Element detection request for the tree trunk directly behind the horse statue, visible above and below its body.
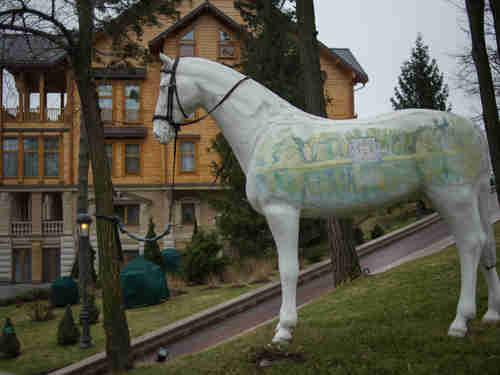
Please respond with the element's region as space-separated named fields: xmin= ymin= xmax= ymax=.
xmin=296 ymin=0 xmax=361 ymax=286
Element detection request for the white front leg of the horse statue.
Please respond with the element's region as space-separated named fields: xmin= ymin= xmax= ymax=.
xmin=263 ymin=203 xmax=300 ymax=343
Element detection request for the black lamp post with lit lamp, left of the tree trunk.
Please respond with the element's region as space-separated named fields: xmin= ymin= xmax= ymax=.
xmin=76 ymin=213 xmax=92 ymax=349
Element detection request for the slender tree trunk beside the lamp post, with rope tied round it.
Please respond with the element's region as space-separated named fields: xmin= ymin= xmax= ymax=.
xmin=72 ymin=0 xmax=132 ymax=373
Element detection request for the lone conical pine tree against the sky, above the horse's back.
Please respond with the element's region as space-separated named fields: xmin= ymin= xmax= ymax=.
xmin=391 ymin=34 xmax=451 ymax=111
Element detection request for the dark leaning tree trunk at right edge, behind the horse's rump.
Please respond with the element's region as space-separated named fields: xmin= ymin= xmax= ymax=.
xmin=465 ymin=0 xmax=500 ymax=206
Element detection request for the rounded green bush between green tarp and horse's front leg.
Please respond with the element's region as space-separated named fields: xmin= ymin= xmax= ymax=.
xmin=182 ymin=229 xmax=229 ymax=284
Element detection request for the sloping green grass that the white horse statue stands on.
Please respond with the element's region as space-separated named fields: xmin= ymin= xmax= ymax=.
xmin=131 ymin=224 xmax=500 ymax=375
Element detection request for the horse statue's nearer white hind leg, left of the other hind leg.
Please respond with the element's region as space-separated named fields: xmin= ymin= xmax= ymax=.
xmin=426 ymin=185 xmax=486 ymax=337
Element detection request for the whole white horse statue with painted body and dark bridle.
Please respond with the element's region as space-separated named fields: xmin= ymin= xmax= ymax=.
xmin=153 ymin=55 xmax=500 ymax=342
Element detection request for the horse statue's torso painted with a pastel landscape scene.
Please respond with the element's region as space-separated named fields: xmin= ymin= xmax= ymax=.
xmin=249 ymin=110 xmax=483 ymax=216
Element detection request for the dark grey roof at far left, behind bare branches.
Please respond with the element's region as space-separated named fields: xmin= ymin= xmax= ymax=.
xmin=0 ymin=33 xmax=66 ymax=67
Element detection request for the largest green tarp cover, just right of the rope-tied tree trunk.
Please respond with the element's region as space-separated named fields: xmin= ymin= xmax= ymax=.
xmin=120 ymin=256 xmax=170 ymax=308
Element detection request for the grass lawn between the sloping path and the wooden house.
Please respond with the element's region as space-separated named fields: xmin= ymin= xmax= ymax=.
xmin=0 ymin=285 xmax=262 ymax=375
